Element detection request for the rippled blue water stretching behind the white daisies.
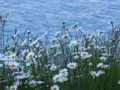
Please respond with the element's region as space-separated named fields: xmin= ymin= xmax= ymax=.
xmin=0 ymin=0 xmax=120 ymax=35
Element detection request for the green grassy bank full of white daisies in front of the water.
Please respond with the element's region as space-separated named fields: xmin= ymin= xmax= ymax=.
xmin=0 ymin=22 xmax=120 ymax=90
